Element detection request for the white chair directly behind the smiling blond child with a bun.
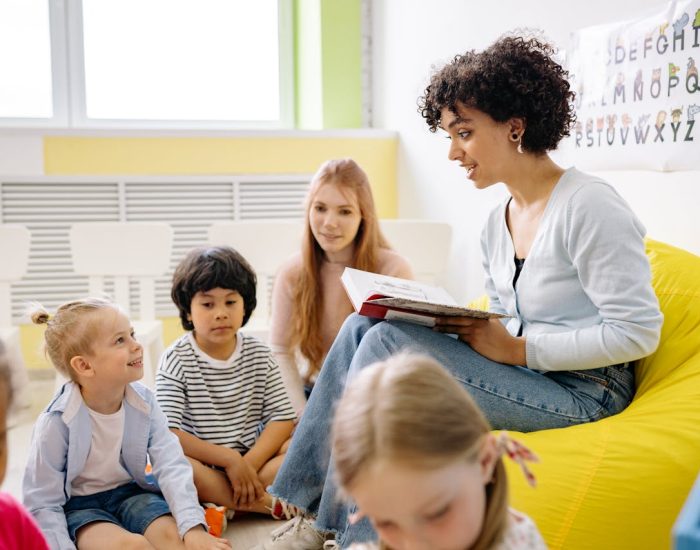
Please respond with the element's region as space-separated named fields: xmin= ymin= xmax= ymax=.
xmin=70 ymin=222 xmax=173 ymax=387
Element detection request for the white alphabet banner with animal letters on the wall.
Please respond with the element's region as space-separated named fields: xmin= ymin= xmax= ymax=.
xmin=564 ymin=0 xmax=700 ymax=171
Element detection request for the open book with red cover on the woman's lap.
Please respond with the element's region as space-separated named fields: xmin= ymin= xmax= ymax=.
xmin=340 ymin=267 xmax=507 ymax=327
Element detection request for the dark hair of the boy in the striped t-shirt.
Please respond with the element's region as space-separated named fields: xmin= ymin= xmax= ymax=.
xmin=170 ymin=246 xmax=258 ymax=330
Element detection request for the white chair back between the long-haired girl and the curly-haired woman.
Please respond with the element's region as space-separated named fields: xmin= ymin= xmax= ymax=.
xmin=379 ymin=219 xmax=452 ymax=284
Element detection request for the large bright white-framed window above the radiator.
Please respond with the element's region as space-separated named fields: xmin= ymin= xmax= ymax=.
xmin=0 ymin=0 xmax=293 ymax=128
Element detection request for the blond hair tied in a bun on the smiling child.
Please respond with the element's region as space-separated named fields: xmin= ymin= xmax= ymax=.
xmin=30 ymin=298 xmax=119 ymax=381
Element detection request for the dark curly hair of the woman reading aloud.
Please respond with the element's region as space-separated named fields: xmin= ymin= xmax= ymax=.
xmin=418 ymin=36 xmax=576 ymax=154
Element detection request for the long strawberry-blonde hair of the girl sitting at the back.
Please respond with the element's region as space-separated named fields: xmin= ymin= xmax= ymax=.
xmin=291 ymin=158 xmax=390 ymax=377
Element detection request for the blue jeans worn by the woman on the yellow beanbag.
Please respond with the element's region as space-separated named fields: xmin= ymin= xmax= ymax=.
xmin=270 ymin=314 xmax=634 ymax=547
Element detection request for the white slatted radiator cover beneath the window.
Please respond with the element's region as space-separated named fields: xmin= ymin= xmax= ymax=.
xmin=0 ymin=174 xmax=311 ymax=323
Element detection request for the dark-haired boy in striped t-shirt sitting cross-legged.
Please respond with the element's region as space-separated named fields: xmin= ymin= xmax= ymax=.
xmin=156 ymin=246 xmax=296 ymax=519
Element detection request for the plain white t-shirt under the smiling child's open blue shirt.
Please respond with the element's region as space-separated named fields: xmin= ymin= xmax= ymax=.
xmin=71 ymin=404 xmax=133 ymax=496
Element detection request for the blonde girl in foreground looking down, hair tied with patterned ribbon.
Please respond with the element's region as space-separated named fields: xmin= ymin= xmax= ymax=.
xmin=325 ymin=354 xmax=546 ymax=550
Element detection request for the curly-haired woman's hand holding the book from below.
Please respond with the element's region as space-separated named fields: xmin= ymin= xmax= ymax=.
xmin=433 ymin=317 xmax=527 ymax=366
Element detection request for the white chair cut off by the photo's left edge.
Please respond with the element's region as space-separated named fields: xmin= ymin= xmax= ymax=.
xmin=0 ymin=224 xmax=31 ymax=424
